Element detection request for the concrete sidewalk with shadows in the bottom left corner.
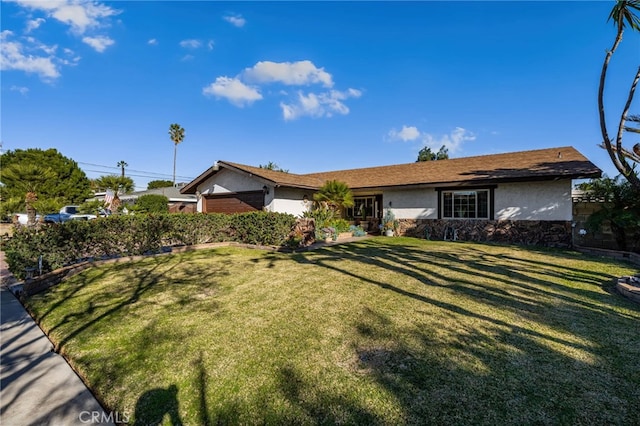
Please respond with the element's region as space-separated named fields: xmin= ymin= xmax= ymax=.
xmin=0 ymin=252 xmax=116 ymax=426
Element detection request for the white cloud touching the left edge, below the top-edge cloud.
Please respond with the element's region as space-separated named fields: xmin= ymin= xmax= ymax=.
xmin=0 ymin=30 xmax=60 ymax=80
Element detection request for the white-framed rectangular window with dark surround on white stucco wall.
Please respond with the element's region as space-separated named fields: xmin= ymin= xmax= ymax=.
xmin=441 ymin=189 xmax=492 ymax=219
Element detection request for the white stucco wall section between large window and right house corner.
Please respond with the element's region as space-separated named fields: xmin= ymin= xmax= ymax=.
xmin=495 ymin=179 xmax=572 ymax=220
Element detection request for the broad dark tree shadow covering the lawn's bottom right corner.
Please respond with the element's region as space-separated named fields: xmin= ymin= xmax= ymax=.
xmin=354 ymin=304 xmax=640 ymax=425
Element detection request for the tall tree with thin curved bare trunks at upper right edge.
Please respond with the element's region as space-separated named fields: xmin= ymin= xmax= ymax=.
xmin=598 ymin=0 xmax=640 ymax=191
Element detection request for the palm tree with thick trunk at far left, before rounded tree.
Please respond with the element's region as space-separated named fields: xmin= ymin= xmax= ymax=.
xmin=2 ymin=163 xmax=58 ymax=226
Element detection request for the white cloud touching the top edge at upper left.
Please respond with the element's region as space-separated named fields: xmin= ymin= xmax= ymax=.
xmin=17 ymin=0 xmax=120 ymax=34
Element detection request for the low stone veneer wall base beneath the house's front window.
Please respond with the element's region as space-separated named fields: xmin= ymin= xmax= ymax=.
xmin=398 ymin=219 xmax=572 ymax=247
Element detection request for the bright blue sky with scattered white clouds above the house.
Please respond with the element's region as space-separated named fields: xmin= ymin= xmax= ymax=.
xmin=0 ymin=0 xmax=640 ymax=189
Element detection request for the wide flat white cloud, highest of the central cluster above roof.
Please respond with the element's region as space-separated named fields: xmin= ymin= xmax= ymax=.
xmin=242 ymin=61 xmax=333 ymax=87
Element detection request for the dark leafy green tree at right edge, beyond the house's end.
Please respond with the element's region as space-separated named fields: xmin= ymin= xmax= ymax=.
xmin=578 ymin=176 xmax=640 ymax=251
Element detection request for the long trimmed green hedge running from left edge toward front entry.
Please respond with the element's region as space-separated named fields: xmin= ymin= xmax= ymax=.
xmin=3 ymin=211 xmax=296 ymax=279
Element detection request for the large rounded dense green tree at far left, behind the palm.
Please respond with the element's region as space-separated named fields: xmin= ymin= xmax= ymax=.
xmin=0 ymin=148 xmax=93 ymax=221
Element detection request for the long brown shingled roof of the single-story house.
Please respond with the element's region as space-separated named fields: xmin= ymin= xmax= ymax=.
xmin=182 ymin=146 xmax=602 ymax=193
